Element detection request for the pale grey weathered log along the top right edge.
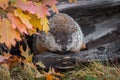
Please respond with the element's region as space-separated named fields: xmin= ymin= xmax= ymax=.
xmin=57 ymin=0 xmax=120 ymax=11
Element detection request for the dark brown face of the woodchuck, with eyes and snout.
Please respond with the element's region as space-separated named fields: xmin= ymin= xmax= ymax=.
xmin=53 ymin=31 xmax=73 ymax=52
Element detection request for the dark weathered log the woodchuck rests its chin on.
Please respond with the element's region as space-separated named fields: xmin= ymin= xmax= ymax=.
xmin=34 ymin=41 xmax=120 ymax=69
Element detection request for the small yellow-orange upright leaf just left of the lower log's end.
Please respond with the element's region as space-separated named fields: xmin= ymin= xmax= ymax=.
xmin=20 ymin=46 xmax=33 ymax=62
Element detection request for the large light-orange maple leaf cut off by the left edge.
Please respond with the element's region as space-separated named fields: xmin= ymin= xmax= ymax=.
xmin=0 ymin=18 xmax=21 ymax=48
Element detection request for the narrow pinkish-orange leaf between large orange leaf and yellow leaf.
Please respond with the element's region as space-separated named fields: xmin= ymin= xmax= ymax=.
xmin=7 ymin=13 xmax=28 ymax=34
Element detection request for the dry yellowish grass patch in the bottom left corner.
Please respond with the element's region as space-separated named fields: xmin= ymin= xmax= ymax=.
xmin=0 ymin=63 xmax=45 ymax=80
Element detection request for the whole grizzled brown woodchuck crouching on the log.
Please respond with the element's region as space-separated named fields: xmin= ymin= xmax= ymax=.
xmin=33 ymin=13 xmax=85 ymax=54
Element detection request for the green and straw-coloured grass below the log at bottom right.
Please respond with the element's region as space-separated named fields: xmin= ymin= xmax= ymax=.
xmin=63 ymin=62 xmax=120 ymax=80
